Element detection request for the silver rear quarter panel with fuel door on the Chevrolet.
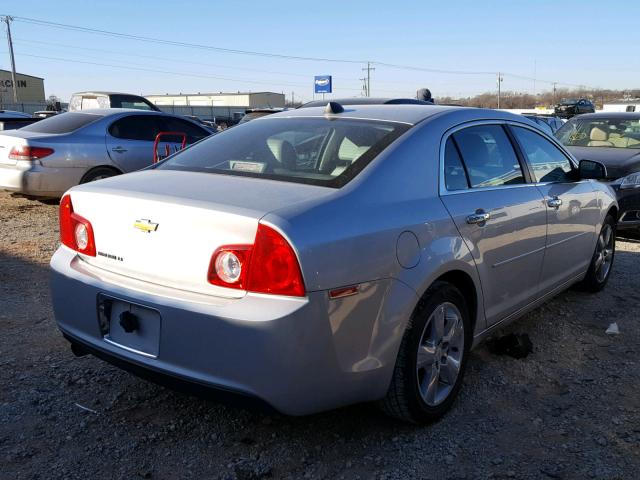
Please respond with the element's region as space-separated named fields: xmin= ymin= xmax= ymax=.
xmin=263 ymin=113 xmax=484 ymax=330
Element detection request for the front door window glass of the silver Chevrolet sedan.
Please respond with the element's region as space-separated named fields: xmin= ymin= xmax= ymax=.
xmin=512 ymin=127 xmax=573 ymax=182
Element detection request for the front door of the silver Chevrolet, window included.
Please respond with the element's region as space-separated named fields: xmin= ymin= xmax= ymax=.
xmin=510 ymin=125 xmax=600 ymax=293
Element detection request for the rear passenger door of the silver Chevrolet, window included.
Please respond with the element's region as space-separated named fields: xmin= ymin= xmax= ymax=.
xmin=440 ymin=123 xmax=547 ymax=325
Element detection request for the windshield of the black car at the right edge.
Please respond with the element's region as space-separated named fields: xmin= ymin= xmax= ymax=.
xmin=556 ymin=118 xmax=640 ymax=148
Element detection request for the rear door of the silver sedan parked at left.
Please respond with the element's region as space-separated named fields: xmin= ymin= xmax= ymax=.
xmin=106 ymin=115 xmax=162 ymax=173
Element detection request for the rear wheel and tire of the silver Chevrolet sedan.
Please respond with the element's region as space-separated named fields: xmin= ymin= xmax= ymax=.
xmin=380 ymin=282 xmax=472 ymax=424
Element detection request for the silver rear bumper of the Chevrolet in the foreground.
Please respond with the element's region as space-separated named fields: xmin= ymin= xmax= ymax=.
xmin=51 ymin=247 xmax=415 ymax=415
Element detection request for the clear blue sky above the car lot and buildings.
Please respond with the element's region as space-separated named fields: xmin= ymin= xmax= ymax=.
xmin=0 ymin=0 xmax=640 ymax=100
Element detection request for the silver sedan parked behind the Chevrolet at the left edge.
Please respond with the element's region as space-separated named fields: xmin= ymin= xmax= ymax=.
xmin=0 ymin=108 xmax=211 ymax=198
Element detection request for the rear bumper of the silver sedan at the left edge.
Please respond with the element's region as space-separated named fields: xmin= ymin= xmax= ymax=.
xmin=0 ymin=161 xmax=86 ymax=197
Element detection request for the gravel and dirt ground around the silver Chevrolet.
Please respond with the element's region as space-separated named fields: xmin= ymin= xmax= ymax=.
xmin=0 ymin=193 xmax=640 ymax=479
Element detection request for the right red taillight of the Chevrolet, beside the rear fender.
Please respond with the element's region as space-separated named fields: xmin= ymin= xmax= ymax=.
xmin=209 ymin=224 xmax=304 ymax=297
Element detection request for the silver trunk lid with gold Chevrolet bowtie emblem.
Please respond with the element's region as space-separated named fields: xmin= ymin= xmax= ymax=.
xmin=70 ymin=170 xmax=335 ymax=298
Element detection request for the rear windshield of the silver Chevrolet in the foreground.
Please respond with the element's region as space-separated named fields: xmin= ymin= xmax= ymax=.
xmin=156 ymin=117 xmax=409 ymax=188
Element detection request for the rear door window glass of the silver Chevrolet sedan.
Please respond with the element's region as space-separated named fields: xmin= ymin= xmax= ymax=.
xmin=453 ymin=125 xmax=525 ymax=188
